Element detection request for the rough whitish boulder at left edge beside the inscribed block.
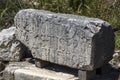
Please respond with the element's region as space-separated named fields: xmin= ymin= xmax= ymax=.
xmin=0 ymin=27 xmax=25 ymax=61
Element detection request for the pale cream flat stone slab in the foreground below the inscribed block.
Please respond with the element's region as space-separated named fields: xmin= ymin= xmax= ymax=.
xmin=3 ymin=62 xmax=78 ymax=80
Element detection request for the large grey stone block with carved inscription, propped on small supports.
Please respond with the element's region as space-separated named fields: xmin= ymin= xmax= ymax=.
xmin=14 ymin=9 xmax=114 ymax=70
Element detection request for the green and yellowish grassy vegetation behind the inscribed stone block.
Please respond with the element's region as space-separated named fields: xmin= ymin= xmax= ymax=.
xmin=0 ymin=0 xmax=120 ymax=49
